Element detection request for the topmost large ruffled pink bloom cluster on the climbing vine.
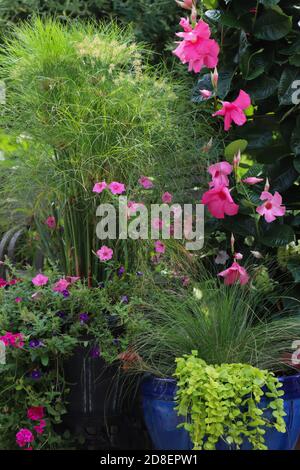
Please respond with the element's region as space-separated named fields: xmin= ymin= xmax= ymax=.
xmin=173 ymin=18 xmax=220 ymax=73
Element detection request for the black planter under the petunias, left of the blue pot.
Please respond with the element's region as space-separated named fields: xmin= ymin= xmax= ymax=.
xmin=63 ymin=346 xmax=150 ymax=450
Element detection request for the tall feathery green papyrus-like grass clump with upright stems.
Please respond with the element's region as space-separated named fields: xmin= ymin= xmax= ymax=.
xmin=1 ymin=19 xmax=206 ymax=280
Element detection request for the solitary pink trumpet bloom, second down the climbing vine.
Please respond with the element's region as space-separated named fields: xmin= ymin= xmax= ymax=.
xmin=213 ymin=90 xmax=251 ymax=131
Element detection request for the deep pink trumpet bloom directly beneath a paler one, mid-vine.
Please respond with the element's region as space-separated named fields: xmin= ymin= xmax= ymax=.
xmin=202 ymin=186 xmax=239 ymax=219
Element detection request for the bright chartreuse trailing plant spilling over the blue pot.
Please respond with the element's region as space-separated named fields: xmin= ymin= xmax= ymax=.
xmin=175 ymin=351 xmax=286 ymax=450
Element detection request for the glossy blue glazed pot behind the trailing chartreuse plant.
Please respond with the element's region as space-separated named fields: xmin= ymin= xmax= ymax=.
xmin=141 ymin=374 xmax=300 ymax=450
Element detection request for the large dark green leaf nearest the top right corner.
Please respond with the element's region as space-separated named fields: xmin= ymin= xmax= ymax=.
xmin=254 ymin=10 xmax=292 ymax=41
